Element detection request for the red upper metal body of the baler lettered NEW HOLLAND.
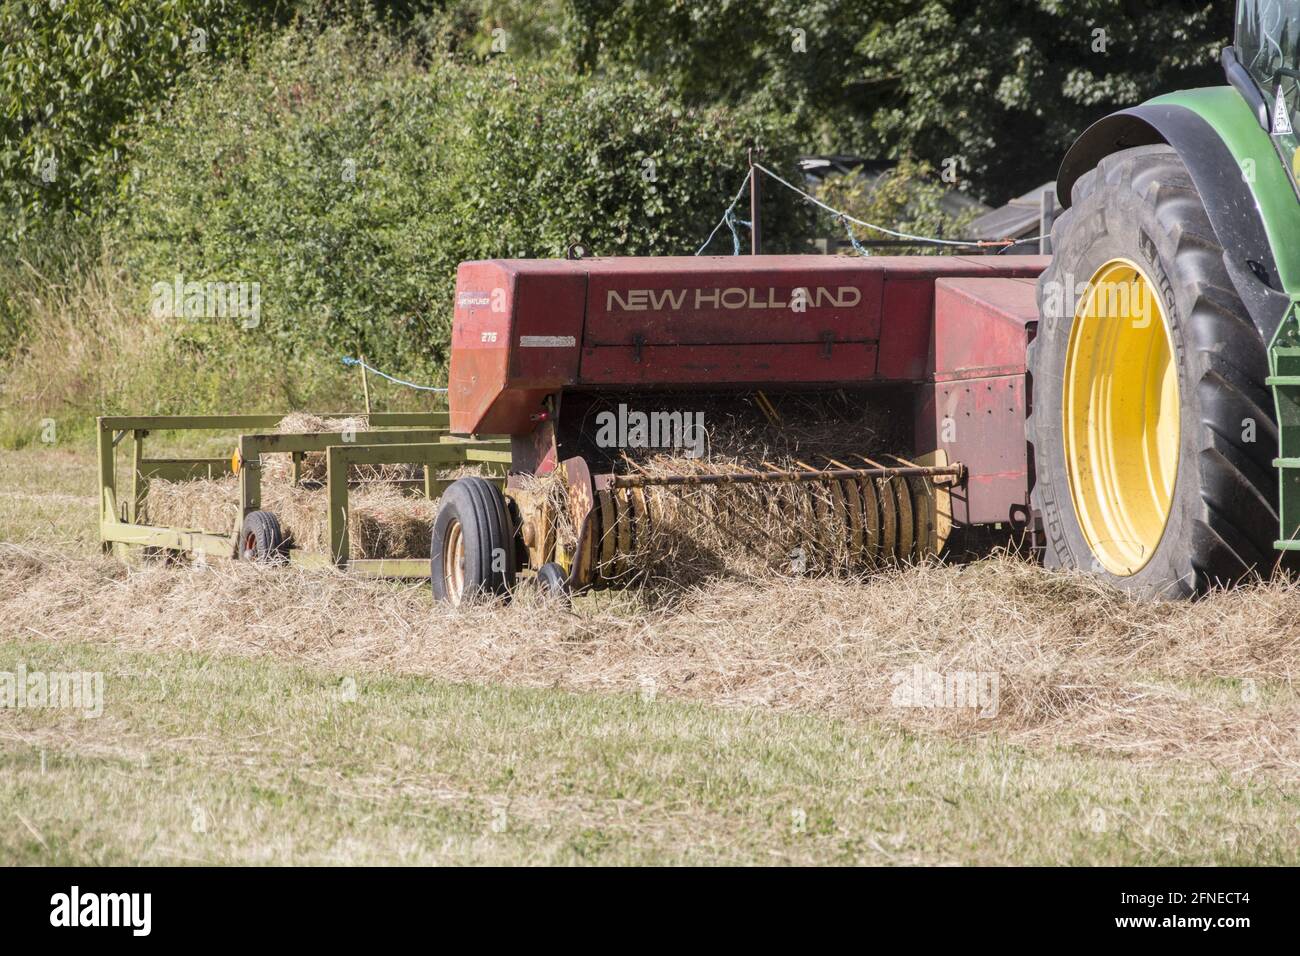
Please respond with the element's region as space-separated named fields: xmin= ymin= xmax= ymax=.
xmin=449 ymin=256 xmax=1047 ymax=437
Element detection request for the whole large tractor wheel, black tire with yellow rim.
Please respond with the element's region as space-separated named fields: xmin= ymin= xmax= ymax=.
xmin=1027 ymin=146 xmax=1278 ymax=597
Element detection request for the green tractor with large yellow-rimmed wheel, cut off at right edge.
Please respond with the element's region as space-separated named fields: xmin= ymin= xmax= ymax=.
xmin=1027 ymin=0 xmax=1300 ymax=597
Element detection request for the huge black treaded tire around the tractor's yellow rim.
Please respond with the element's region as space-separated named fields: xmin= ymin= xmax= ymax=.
xmin=1026 ymin=146 xmax=1278 ymax=597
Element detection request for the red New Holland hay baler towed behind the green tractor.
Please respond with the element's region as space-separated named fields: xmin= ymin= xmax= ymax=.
xmin=434 ymin=256 xmax=1048 ymax=600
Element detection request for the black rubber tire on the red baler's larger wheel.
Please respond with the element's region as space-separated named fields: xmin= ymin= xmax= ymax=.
xmin=429 ymin=477 xmax=516 ymax=604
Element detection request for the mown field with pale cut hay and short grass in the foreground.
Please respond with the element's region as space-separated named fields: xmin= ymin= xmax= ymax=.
xmin=0 ymin=445 xmax=1300 ymax=865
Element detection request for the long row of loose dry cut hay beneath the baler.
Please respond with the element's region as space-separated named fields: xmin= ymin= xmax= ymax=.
xmin=0 ymin=545 xmax=1300 ymax=786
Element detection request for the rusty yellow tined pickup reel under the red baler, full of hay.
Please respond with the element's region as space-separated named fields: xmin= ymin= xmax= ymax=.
xmin=524 ymin=453 xmax=963 ymax=591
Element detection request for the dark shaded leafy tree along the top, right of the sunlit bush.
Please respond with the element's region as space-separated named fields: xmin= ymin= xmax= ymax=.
xmin=569 ymin=0 xmax=1232 ymax=202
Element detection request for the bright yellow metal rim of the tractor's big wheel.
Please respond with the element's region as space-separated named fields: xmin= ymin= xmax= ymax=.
xmin=1063 ymin=259 xmax=1180 ymax=576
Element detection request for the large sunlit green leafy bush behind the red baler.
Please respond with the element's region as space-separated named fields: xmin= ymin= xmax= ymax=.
xmin=114 ymin=29 xmax=807 ymax=378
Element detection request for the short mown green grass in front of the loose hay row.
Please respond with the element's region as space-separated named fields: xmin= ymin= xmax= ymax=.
xmin=0 ymin=640 xmax=1300 ymax=864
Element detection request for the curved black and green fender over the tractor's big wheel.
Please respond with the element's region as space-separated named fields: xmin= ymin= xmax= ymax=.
xmin=1057 ymin=97 xmax=1300 ymax=342
